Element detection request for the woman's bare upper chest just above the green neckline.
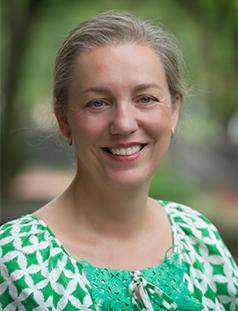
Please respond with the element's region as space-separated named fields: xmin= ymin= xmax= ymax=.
xmin=62 ymin=228 xmax=173 ymax=270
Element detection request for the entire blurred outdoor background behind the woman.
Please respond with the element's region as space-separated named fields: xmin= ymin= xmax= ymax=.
xmin=1 ymin=0 xmax=238 ymax=259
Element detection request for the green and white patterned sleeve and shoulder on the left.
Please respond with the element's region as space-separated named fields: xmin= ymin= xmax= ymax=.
xmin=0 ymin=215 xmax=92 ymax=310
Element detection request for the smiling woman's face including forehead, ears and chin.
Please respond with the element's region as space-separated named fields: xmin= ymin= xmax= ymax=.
xmin=56 ymin=43 xmax=179 ymax=187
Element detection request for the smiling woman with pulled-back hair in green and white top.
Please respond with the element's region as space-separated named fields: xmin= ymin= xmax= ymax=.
xmin=0 ymin=12 xmax=238 ymax=310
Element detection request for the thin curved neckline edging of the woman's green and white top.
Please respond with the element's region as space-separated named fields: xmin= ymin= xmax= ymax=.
xmin=27 ymin=200 xmax=180 ymax=273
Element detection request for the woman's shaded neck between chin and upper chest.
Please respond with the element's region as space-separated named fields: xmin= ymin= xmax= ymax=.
xmin=63 ymin=175 xmax=151 ymax=237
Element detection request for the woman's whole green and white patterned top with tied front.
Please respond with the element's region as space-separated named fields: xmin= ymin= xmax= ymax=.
xmin=0 ymin=201 xmax=238 ymax=311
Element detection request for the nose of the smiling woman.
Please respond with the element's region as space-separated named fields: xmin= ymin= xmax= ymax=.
xmin=110 ymin=103 xmax=138 ymax=135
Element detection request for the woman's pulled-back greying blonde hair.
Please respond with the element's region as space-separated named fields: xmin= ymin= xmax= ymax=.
xmin=54 ymin=11 xmax=185 ymax=113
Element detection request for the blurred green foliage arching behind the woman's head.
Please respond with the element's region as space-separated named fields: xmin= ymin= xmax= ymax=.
xmin=4 ymin=0 xmax=237 ymax=122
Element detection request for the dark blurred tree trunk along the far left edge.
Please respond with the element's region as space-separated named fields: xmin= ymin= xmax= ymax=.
xmin=1 ymin=0 xmax=41 ymax=201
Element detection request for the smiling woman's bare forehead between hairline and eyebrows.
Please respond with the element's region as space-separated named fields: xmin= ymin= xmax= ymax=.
xmin=71 ymin=43 xmax=167 ymax=92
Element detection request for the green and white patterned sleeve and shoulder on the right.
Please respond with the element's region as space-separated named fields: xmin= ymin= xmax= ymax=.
xmin=162 ymin=202 xmax=238 ymax=310
